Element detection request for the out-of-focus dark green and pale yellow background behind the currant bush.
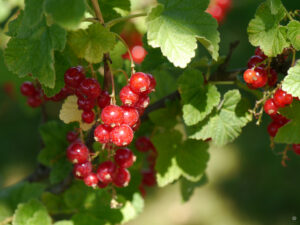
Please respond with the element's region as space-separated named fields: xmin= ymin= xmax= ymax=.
xmin=0 ymin=0 xmax=300 ymax=225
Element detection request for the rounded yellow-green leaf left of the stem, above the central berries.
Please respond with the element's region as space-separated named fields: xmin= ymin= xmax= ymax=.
xmin=69 ymin=23 xmax=116 ymax=63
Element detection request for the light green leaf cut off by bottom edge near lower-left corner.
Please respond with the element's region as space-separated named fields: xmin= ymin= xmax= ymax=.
xmin=12 ymin=200 xmax=51 ymax=225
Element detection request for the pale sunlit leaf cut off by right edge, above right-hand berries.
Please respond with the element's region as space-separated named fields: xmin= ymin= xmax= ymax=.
xmin=282 ymin=60 xmax=300 ymax=98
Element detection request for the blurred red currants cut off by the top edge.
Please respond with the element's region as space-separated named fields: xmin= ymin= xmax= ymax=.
xmin=206 ymin=0 xmax=232 ymax=23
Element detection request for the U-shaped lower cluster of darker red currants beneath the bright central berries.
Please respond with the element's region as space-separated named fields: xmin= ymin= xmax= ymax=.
xmin=67 ymin=131 xmax=135 ymax=188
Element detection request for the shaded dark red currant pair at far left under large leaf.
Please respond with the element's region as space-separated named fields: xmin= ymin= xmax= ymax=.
xmin=20 ymin=81 xmax=46 ymax=108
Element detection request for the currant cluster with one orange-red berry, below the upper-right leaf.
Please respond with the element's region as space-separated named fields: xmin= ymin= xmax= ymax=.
xmin=244 ymin=47 xmax=278 ymax=89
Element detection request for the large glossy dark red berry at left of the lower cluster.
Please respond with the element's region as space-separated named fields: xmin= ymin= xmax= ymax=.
xmin=67 ymin=141 xmax=89 ymax=163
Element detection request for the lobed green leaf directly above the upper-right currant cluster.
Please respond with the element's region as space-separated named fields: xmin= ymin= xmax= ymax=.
xmin=247 ymin=2 xmax=289 ymax=57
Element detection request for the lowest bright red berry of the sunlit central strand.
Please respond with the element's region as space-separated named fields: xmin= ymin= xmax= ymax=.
xmin=110 ymin=124 xmax=133 ymax=146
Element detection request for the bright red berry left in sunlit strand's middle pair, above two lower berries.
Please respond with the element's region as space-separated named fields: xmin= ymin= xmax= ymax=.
xmin=101 ymin=105 xmax=124 ymax=127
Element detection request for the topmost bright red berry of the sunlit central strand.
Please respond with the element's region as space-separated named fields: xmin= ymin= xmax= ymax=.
xmin=129 ymin=72 xmax=151 ymax=94
